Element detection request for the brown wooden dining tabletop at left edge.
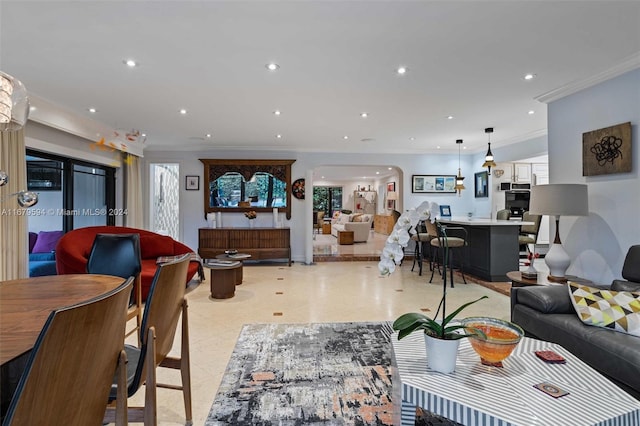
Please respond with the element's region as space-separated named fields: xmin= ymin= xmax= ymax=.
xmin=0 ymin=274 xmax=123 ymax=365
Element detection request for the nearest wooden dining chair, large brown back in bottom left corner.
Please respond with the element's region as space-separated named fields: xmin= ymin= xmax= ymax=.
xmin=2 ymin=278 xmax=133 ymax=426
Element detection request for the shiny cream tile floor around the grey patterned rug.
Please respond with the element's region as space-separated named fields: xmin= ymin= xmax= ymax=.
xmin=129 ymin=262 xmax=509 ymax=425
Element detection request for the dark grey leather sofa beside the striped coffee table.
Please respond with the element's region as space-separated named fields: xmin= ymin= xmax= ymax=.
xmin=511 ymin=245 xmax=640 ymax=399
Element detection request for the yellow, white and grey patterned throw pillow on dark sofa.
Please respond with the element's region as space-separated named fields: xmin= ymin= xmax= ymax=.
xmin=568 ymin=281 xmax=640 ymax=336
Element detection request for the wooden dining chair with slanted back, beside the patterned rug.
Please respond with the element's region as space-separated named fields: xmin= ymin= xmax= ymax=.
xmin=104 ymin=254 xmax=192 ymax=425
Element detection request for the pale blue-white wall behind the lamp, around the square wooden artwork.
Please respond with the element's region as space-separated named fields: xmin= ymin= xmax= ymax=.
xmin=548 ymin=69 xmax=640 ymax=283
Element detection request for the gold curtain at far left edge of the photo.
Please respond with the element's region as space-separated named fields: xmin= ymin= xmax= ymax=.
xmin=0 ymin=129 xmax=29 ymax=281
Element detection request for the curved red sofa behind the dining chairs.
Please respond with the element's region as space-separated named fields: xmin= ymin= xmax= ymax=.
xmin=56 ymin=226 xmax=204 ymax=300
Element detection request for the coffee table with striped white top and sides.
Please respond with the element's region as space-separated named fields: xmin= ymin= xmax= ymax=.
xmin=391 ymin=333 xmax=640 ymax=426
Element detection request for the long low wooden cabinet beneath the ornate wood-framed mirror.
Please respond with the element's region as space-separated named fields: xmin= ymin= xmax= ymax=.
xmin=198 ymin=228 xmax=291 ymax=266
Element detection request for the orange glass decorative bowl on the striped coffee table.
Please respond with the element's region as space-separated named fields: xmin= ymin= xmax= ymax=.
xmin=461 ymin=317 xmax=524 ymax=366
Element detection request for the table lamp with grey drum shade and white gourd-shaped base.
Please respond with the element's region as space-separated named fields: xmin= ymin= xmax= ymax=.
xmin=529 ymin=183 xmax=589 ymax=282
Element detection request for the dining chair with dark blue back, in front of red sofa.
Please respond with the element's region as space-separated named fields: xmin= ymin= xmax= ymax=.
xmin=87 ymin=234 xmax=142 ymax=341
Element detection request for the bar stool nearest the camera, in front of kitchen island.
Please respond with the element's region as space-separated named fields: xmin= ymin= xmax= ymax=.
xmin=429 ymin=222 xmax=468 ymax=288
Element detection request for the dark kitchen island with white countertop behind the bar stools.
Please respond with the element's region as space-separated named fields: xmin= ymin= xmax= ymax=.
xmin=439 ymin=217 xmax=532 ymax=281
